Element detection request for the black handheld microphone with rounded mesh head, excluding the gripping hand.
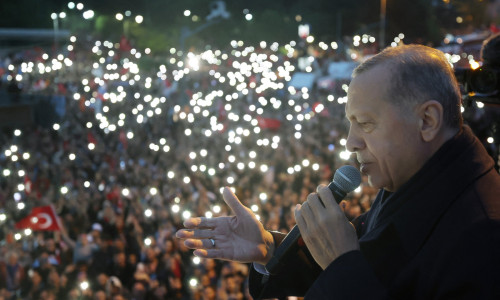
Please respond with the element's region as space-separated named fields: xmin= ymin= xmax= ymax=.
xmin=266 ymin=166 xmax=361 ymax=274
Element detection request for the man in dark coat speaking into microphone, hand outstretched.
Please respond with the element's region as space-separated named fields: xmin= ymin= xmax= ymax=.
xmin=177 ymin=45 xmax=500 ymax=299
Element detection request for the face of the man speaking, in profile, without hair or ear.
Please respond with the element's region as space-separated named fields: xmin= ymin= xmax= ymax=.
xmin=346 ymin=65 xmax=424 ymax=191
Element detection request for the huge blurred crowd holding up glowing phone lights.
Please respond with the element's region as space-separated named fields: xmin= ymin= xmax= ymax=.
xmin=0 ymin=29 xmax=498 ymax=299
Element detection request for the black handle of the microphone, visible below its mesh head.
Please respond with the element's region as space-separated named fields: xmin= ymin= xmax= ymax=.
xmin=266 ymin=181 xmax=346 ymax=275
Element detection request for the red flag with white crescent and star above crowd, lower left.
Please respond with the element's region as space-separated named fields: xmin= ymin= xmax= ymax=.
xmin=15 ymin=205 xmax=61 ymax=231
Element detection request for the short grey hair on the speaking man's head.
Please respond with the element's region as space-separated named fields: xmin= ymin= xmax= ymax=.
xmin=352 ymin=45 xmax=463 ymax=128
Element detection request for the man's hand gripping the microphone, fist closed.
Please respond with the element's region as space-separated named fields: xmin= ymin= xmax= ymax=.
xmin=295 ymin=186 xmax=359 ymax=270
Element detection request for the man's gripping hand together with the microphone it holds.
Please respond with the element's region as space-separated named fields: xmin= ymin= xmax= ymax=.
xmin=266 ymin=166 xmax=361 ymax=274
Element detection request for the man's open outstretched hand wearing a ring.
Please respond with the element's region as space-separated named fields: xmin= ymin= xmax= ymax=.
xmin=176 ymin=187 xmax=274 ymax=265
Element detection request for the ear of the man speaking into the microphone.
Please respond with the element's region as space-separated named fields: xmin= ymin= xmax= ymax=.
xmin=418 ymin=100 xmax=443 ymax=142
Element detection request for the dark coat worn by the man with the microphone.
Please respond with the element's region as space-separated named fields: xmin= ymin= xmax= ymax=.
xmin=250 ymin=127 xmax=500 ymax=299
